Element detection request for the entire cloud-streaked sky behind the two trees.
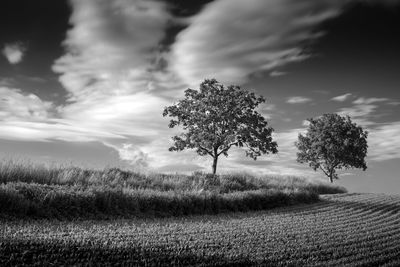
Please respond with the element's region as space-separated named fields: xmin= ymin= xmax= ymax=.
xmin=0 ymin=0 xmax=400 ymax=193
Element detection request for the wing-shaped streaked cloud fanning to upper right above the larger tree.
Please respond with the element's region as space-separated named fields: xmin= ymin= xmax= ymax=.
xmin=170 ymin=0 xmax=344 ymax=85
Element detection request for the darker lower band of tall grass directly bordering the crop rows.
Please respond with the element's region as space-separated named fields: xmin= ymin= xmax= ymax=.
xmin=0 ymin=183 xmax=318 ymax=219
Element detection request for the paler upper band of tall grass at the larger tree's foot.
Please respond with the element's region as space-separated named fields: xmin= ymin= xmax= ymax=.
xmin=0 ymin=160 xmax=346 ymax=194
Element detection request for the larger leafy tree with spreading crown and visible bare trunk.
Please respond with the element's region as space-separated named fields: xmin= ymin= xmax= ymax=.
xmin=163 ymin=79 xmax=278 ymax=174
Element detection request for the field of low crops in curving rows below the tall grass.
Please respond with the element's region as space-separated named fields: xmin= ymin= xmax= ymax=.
xmin=0 ymin=193 xmax=400 ymax=266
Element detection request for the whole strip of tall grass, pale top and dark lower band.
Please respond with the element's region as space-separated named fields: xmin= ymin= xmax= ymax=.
xmin=0 ymin=160 xmax=345 ymax=219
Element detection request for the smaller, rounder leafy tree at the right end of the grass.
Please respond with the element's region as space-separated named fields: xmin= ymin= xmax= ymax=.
xmin=296 ymin=114 xmax=368 ymax=183
